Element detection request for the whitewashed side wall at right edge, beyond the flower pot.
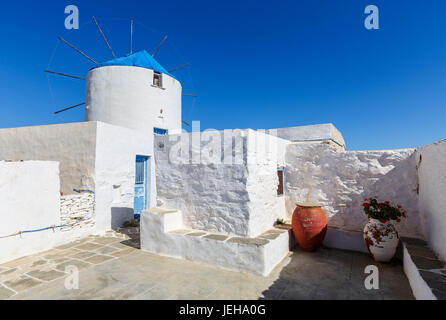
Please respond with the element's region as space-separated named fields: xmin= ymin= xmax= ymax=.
xmin=416 ymin=140 xmax=446 ymax=261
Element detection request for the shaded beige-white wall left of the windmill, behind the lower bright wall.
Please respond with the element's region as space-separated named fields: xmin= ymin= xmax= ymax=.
xmin=0 ymin=122 xmax=96 ymax=195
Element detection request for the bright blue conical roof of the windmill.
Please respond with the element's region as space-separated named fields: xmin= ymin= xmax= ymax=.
xmin=93 ymin=50 xmax=175 ymax=78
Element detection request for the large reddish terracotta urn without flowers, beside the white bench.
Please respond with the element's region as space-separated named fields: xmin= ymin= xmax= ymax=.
xmin=292 ymin=202 xmax=327 ymax=251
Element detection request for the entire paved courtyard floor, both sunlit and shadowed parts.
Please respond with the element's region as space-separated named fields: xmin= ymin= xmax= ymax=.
xmin=0 ymin=228 xmax=413 ymax=299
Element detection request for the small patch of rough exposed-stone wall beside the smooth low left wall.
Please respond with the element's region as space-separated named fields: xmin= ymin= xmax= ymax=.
xmin=60 ymin=193 xmax=96 ymax=233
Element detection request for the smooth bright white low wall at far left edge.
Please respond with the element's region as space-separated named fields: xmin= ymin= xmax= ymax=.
xmin=0 ymin=161 xmax=60 ymax=263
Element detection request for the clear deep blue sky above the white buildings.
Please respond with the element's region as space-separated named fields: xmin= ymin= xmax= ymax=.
xmin=0 ymin=0 xmax=446 ymax=150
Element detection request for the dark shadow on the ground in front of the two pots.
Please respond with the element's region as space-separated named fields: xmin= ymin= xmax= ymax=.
xmin=261 ymin=247 xmax=413 ymax=300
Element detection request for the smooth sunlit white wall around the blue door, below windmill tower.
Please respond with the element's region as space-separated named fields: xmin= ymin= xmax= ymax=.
xmin=95 ymin=122 xmax=156 ymax=233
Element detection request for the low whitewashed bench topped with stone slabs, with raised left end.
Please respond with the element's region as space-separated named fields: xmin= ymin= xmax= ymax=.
xmin=140 ymin=210 xmax=289 ymax=276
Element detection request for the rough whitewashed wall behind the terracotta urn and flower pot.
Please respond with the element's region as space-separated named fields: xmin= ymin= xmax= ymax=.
xmin=285 ymin=144 xmax=424 ymax=238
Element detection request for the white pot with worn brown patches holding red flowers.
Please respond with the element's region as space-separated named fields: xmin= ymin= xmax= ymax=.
xmin=364 ymin=219 xmax=399 ymax=262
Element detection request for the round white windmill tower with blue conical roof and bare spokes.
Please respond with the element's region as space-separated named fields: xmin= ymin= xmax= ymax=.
xmin=45 ymin=17 xmax=197 ymax=132
